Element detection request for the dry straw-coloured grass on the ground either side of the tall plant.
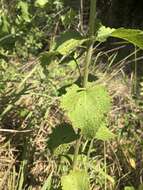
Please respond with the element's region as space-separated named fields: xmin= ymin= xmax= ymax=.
xmin=0 ymin=51 xmax=143 ymax=190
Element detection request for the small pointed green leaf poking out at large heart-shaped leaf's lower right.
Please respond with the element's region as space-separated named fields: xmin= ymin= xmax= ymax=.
xmin=96 ymin=125 xmax=115 ymax=141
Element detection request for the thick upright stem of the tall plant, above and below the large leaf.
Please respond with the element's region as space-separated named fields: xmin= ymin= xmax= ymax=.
xmin=72 ymin=0 xmax=96 ymax=170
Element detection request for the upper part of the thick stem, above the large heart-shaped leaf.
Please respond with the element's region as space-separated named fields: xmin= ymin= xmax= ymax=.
xmin=83 ymin=0 xmax=96 ymax=88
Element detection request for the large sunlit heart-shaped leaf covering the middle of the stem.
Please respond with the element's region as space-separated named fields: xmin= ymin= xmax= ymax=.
xmin=61 ymin=85 xmax=111 ymax=138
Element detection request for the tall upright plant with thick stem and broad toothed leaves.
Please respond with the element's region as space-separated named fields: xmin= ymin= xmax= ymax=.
xmin=40 ymin=0 xmax=143 ymax=190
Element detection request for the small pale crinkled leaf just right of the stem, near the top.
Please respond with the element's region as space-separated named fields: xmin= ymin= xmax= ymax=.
xmin=96 ymin=25 xmax=115 ymax=42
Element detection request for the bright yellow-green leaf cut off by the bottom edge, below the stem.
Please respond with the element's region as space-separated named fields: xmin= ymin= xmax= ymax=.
xmin=61 ymin=171 xmax=90 ymax=190
